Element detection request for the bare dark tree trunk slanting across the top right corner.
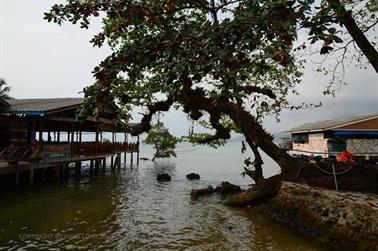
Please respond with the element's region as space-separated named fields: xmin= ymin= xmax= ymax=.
xmin=327 ymin=0 xmax=378 ymax=73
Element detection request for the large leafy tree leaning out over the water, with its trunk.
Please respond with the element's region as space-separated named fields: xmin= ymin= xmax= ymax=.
xmin=45 ymin=0 xmax=372 ymax=206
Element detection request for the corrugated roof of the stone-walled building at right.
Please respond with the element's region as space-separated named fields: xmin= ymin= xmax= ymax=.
xmin=290 ymin=114 xmax=378 ymax=132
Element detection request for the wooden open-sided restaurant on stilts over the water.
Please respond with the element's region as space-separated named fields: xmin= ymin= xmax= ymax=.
xmin=0 ymin=98 xmax=139 ymax=186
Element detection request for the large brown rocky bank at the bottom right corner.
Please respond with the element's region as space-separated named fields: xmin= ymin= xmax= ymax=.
xmin=252 ymin=182 xmax=378 ymax=251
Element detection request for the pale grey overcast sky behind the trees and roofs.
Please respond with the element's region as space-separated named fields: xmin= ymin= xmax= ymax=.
xmin=0 ymin=0 xmax=378 ymax=135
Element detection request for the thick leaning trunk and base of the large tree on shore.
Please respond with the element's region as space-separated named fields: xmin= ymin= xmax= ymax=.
xmin=222 ymin=102 xmax=299 ymax=206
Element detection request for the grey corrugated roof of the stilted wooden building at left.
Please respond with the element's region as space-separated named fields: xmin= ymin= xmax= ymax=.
xmin=1 ymin=98 xmax=84 ymax=113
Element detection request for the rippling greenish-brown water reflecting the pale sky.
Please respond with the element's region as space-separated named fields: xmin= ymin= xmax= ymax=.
xmin=0 ymin=144 xmax=324 ymax=250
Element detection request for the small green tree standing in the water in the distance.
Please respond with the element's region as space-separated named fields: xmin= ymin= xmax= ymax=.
xmin=144 ymin=122 xmax=180 ymax=161
